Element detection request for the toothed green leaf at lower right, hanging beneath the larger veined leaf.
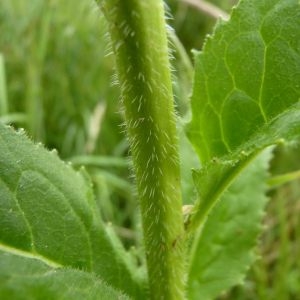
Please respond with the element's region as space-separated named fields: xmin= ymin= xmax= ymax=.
xmin=188 ymin=149 xmax=271 ymax=300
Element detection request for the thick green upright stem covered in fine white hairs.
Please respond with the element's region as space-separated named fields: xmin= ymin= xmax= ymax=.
xmin=98 ymin=0 xmax=184 ymax=299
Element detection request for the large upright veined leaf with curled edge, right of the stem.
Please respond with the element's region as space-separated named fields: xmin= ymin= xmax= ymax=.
xmin=187 ymin=0 xmax=300 ymax=228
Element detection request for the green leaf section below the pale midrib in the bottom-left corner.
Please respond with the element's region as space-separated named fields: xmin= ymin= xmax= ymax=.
xmin=0 ymin=248 xmax=129 ymax=300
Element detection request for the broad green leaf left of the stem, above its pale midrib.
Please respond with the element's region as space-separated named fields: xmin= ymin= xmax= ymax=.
xmin=0 ymin=124 xmax=143 ymax=296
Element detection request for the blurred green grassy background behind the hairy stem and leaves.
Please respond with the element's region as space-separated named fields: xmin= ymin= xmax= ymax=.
xmin=0 ymin=0 xmax=300 ymax=300
